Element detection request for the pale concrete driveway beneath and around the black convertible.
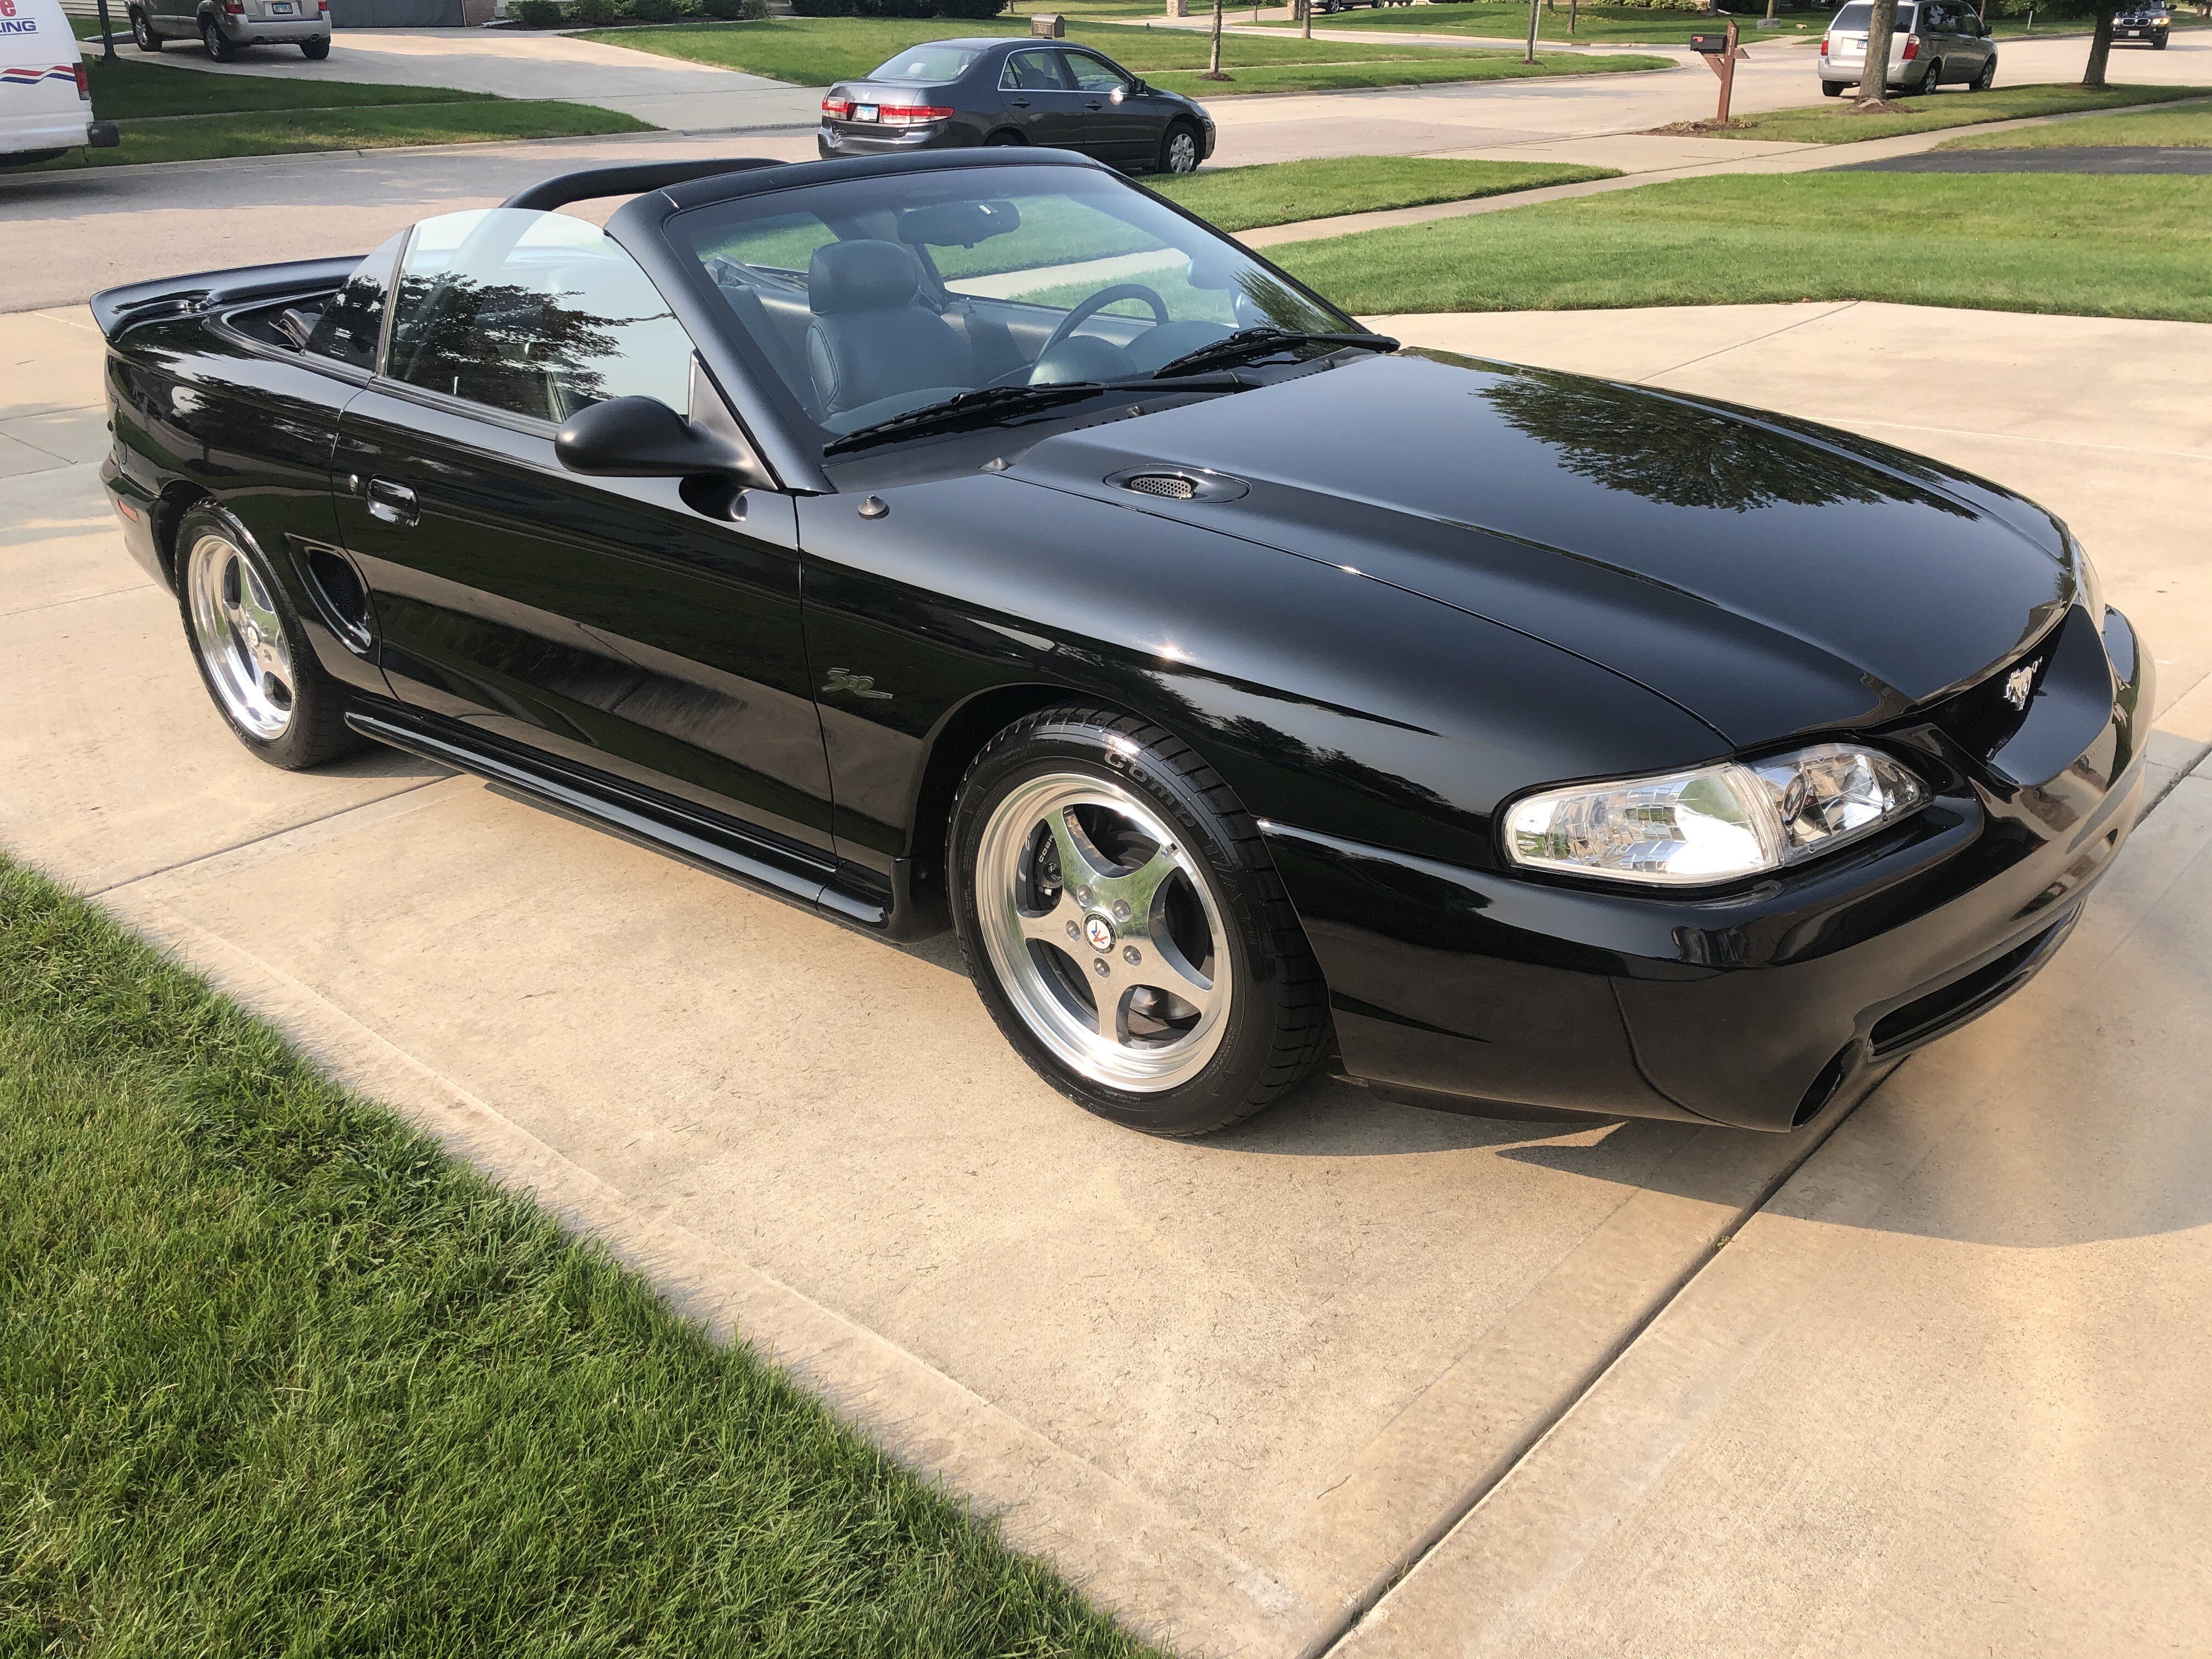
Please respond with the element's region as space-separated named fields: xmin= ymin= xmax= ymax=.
xmin=0 ymin=283 xmax=2212 ymax=1659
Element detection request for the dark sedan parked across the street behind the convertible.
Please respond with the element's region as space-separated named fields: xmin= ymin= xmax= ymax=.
xmin=816 ymin=38 xmax=1215 ymax=172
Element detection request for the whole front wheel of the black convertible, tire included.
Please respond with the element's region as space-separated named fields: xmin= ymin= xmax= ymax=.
xmin=949 ymin=710 xmax=1327 ymax=1135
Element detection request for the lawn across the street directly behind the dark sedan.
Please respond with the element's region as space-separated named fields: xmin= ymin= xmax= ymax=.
xmin=579 ymin=18 xmax=1583 ymax=86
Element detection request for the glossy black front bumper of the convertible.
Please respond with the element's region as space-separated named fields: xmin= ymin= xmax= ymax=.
xmin=1269 ymin=611 xmax=2152 ymax=1130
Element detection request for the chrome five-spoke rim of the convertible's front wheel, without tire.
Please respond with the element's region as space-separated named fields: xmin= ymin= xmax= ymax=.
xmin=975 ymin=772 xmax=1234 ymax=1093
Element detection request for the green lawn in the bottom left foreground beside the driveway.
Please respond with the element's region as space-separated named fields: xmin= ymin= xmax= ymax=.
xmin=0 ymin=862 xmax=1146 ymax=1659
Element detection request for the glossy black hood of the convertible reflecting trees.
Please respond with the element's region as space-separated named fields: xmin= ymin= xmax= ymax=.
xmin=1013 ymin=354 xmax=2073 ymax=748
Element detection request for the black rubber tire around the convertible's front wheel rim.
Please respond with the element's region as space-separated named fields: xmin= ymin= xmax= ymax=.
xmin=947 ymin=706 xmax=1329 ymax=1135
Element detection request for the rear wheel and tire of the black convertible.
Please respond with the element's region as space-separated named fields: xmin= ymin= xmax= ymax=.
xmin=177 ymin=502 xmax=360 ymax=768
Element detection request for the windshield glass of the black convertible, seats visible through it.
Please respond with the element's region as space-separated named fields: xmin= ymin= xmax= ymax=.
xmin=670 ymin=166 xmax=1356 ymax=455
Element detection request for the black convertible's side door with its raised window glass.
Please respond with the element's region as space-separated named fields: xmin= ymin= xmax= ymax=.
xmin=334 ymin=208 xmax=830 ymax=854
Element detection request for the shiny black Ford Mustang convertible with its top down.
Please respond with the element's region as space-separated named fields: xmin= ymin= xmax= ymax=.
xmin=93 ymin=150 xmax=2150 ymax=1135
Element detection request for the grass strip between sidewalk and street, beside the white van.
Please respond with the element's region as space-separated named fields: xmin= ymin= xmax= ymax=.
xmin=26 ymin=99 xmax=652 ymax=170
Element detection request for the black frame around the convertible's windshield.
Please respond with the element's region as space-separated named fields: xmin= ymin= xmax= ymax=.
xmin=606 ymin=150 xmax=1361 ymax=493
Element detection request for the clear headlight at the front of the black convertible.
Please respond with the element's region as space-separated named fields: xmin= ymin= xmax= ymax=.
xmin=1504 ymin=743 xmax=1927 ymax=887
